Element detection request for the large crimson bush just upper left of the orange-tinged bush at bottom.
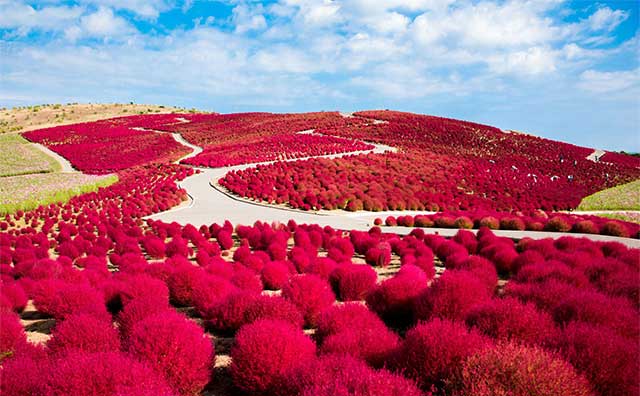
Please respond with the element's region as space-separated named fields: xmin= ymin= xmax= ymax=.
xmin=394 ymin=319 xmax=491 ymax=390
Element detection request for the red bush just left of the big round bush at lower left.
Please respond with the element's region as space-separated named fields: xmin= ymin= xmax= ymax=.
xmin=47 ymin=314 xmax=120 ymax=354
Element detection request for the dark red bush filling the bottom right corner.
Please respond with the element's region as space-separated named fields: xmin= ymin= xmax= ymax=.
xmin=557 ymin=322 xmax=640 ymax=396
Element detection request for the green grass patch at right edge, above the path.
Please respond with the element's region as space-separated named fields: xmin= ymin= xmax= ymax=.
xmin=576 ymin=180 xmax=640 ymax=210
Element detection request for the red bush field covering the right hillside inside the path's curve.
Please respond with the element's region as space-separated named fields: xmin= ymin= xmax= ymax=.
xmin=219 ymin=111 xmax=640 ymax=212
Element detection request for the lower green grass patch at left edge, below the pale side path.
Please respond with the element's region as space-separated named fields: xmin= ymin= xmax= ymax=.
xmin=0 ymin=173 xmax=118 ymax=215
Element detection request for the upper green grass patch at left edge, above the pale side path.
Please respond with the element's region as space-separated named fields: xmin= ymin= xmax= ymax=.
xmin=0 ymin=134 xmax=62 ymax=177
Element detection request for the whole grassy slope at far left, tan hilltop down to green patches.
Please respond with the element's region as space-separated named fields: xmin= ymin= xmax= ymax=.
xmin=0 ymin=103 xmax=205 ymax=214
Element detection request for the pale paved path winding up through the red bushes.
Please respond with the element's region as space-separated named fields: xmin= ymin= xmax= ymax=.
xmin=148 ymin=124 xmax=640 ymax=248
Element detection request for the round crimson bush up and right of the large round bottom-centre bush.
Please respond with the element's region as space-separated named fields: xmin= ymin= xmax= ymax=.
xmin=282 ymin=274 xmax=336 ymax=327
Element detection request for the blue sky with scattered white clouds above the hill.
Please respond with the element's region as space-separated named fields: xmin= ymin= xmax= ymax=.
xmin=0 ymin=0 xmax=640 ymax=151
